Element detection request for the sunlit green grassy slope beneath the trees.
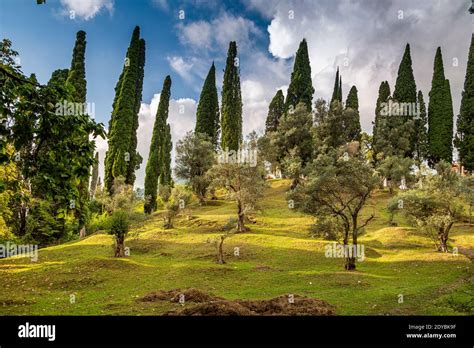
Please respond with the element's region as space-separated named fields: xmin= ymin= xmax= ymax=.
xmin=0 ymin=181 xmax=474 ymax=315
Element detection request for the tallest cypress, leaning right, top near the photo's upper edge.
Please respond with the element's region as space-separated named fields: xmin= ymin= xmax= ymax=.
xmin=104 ymin=26 xmax=145 ymax=193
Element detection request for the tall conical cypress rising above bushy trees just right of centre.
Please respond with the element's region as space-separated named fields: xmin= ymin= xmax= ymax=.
xmin=285 ymin=39 xmax=314 ymax=112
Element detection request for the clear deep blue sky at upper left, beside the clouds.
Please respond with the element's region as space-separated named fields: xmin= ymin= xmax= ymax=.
xmin=0 ymin=0 xmax=264 ymax=121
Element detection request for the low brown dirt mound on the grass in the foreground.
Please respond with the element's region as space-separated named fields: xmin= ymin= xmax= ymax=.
xmin=139 ymin=288 xmax=335 ymax=316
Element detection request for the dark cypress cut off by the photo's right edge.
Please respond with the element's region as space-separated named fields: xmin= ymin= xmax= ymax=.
xmin=455 ymin=34 xmax=474 ymax=172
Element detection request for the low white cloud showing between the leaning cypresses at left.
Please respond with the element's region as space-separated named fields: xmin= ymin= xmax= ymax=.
xmin=96 ymin=93 xmax=197 ymax=187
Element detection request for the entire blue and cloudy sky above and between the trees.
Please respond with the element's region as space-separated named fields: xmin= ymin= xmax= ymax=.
xmin=0 ymin=0 xmax=474 ymax=186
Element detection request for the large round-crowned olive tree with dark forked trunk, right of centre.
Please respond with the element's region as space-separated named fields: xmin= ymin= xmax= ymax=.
xmin=288 ymin=148 xmax=379 ymax=270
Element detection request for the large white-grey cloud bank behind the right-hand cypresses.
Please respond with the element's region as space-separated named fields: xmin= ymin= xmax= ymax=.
xmin=258 ymin=0 xmax=471 ymax=132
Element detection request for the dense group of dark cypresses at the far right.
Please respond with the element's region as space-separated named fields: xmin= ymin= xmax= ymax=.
xmin=373 ymin=38 xmax=468 ymax=171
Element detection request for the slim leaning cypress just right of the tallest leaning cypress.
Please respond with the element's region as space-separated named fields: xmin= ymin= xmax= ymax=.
xmin=144 ymin=76 xmax=171 ymax=214
